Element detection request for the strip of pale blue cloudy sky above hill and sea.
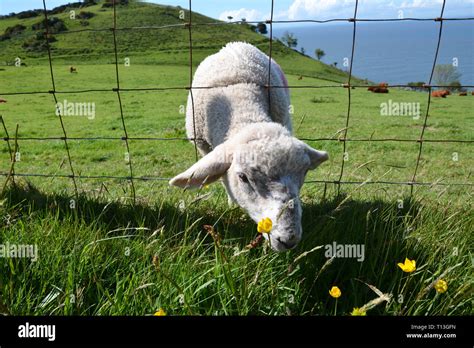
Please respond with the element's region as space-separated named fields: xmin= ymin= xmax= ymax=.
xmin=0 ymin=0 xmax=474 ymax=21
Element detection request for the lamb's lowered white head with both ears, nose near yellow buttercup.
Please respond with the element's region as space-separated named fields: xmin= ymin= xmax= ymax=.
xmin=170 ymin=124 xmax=328 ymax=251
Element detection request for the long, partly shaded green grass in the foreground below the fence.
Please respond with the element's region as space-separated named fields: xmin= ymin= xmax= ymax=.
xmin=0 ymin=186 xmax=473 ymax=315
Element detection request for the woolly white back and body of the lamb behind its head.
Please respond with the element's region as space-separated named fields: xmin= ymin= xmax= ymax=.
xmin=186 ymin=42 xmax=291 ymax=153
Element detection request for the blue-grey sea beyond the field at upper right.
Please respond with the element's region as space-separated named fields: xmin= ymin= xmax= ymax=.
xmin=273 ymin=20 xmax=474 ymax=85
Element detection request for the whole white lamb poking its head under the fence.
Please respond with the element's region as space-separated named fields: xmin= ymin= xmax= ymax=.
xmin=170 ymin=42 xmax=328 ymax=251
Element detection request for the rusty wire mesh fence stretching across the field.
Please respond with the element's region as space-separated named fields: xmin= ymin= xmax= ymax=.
xmin=0 ymin=0 xmax=474 ymax=201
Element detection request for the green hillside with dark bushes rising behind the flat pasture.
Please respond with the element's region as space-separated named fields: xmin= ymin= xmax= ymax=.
xmin=0 ymin=0 xmax=364 ymax=82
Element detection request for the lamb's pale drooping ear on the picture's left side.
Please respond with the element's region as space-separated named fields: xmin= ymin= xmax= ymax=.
xmin=169 ymin=143 xmax=232 ymax=188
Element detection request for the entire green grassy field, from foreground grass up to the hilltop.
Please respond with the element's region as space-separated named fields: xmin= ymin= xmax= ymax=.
xmin=0 ymin=0 xmax=474 ymax=315
